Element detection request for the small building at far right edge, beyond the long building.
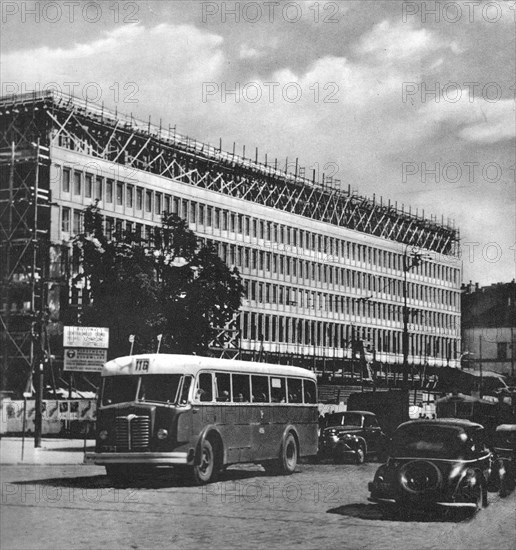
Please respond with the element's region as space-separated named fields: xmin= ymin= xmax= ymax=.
xmin=462 ymin=279 xmax=516 ymax=378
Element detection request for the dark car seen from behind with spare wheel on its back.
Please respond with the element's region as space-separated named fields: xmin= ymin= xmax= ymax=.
xmin=369 ymin=418 xmax=494 ymax=512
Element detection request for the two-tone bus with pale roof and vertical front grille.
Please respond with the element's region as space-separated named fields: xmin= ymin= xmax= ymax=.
xmin=86 ymin=354 xmax=318 ymax=484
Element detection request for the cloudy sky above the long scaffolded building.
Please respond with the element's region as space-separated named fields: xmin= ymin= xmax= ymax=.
xmin=0 ymin=0 xmax=516 ymax=285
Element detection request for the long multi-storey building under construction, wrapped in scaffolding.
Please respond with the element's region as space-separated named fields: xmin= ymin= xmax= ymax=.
xmin=0 ymin=91 xmax=461 ymax=398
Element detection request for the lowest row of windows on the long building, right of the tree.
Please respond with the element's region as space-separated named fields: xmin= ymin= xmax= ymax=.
xmin=241 ymin=312 xmax=457 ymax=359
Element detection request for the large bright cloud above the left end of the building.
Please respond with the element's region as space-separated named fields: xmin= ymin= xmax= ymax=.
xmin=1 ymin=23 xmax=224 ymax=116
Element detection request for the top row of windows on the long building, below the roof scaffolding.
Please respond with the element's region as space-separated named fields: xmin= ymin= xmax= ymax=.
xmin=62 ymin=168 xmax=459 ymax=283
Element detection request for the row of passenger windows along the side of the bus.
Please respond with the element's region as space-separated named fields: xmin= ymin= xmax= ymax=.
xmin=196 ymin=372 xmax=317 ymax=403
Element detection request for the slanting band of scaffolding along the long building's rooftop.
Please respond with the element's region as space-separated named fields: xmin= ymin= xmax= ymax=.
xmin=0 ymin=91 xmax=459 ymax=256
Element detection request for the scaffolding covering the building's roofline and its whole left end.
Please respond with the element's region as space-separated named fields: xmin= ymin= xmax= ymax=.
xmin=0 ymin=91 xmax=459 ymax=387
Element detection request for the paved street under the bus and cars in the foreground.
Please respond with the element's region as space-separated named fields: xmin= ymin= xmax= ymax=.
xmin=0 ymin=463 xmax=516 ymax=550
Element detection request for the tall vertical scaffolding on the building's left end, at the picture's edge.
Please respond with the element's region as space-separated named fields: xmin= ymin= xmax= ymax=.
xmin=0 ymin=99 xmax=50 ymax=389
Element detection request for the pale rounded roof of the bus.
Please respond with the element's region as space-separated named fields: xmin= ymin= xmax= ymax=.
xmin=102 ymin=353 xmax=316 ymax=380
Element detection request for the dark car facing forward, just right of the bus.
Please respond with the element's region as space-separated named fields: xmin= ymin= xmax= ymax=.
xmin=318 ymin=411 xmax=387 ymax=464
